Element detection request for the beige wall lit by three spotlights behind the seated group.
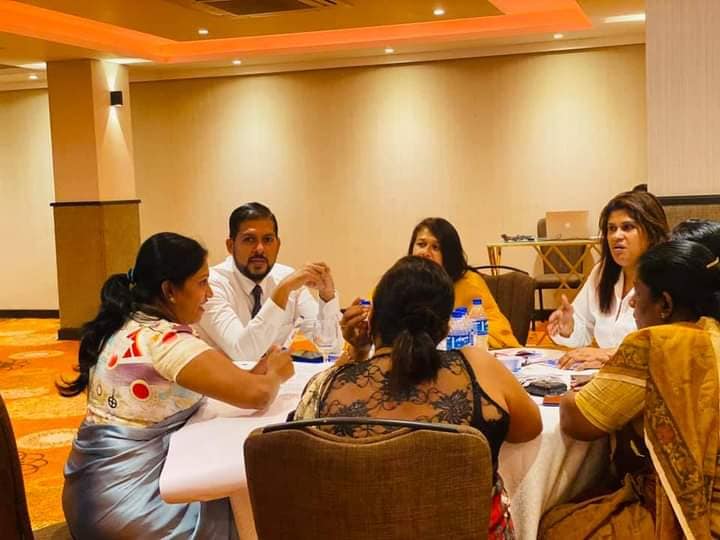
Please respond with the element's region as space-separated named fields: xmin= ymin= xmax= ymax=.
xmin=131 ymin=46 xmax=646 ymax=300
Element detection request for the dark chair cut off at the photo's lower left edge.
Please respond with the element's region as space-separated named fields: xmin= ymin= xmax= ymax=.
xmin=0 ymin=394 xmax=72 ymax=540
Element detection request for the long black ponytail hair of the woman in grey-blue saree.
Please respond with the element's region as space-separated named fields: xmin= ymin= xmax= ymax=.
xmin=56 ymin=232 xmax=207 ymax=397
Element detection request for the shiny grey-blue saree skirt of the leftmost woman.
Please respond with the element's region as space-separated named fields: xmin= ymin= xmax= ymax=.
xmin=63 ymin=407 xmax=237 ymax=539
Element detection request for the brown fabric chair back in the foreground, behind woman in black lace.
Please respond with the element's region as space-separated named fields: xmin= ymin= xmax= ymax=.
xmin=245 ymin=418 xmax=493 ymax=540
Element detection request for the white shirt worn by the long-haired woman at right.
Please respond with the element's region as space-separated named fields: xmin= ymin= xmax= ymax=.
xmin=551 ymin=264 xmax=637 ymax=349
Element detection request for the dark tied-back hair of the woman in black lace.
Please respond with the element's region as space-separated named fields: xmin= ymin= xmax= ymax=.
xmin=370 ymin=256 xmax=455 ymax=393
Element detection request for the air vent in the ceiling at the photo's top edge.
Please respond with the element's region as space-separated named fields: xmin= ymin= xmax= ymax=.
xmin=175 ymin=0 xmax=350 ymax=17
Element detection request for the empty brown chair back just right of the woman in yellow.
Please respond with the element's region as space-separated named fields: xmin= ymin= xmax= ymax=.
xmin=472 ymin=265 xmax=535 ymax=345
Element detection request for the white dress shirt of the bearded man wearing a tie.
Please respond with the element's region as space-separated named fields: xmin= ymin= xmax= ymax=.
xmin=196 ymin=256 xmax=340 ymax=362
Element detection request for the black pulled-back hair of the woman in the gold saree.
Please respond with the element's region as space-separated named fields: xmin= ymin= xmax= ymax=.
xmin=638 ymin=240 xmax=720 ymax=320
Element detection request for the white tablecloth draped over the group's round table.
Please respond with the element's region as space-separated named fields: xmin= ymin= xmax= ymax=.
xmin=160 ymin=352 xmax=607 ymax=540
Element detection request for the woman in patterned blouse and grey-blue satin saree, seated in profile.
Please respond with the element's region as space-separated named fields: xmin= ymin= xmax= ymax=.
xmin=58 ymin=233 xmax=292 ymax=540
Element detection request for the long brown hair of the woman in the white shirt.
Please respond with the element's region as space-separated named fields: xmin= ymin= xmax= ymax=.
xmin=597 ymin=191 xmax=669 ymax=313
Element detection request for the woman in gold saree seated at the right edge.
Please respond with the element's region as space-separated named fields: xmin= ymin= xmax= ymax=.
xmin=540 ymin=240 xmax=720 ymax=539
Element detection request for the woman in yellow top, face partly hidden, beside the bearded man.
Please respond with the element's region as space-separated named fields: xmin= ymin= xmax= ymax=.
xmin=408 ymin=218 xmax=521 ymax=349
